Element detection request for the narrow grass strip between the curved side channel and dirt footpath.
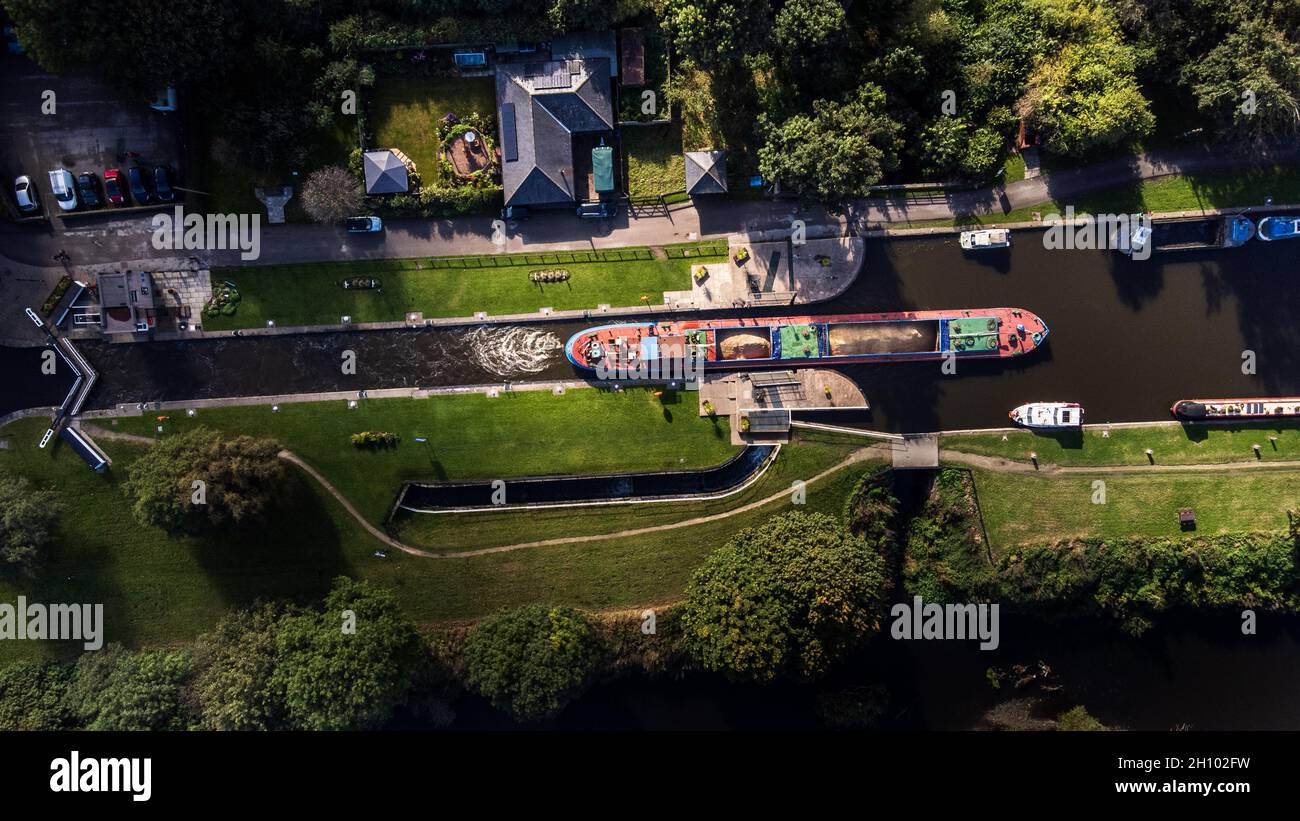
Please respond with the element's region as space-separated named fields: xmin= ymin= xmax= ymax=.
xmin=393 ymin=431 xmax=863 ymax=551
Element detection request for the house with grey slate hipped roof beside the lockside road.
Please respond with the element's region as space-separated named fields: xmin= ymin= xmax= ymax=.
xmin=497 ymin=52 xmax=615 ymax=207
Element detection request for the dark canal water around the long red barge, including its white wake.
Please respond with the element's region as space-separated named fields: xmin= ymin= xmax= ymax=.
xmin=7 ymin=231 xmax=1300 ymax=431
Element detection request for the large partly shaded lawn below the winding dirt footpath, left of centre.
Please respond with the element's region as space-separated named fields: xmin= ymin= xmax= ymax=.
xmin=0 ymin=420 xmax=879 ymax=663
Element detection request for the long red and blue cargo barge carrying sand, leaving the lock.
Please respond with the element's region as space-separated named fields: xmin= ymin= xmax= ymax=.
xmin=564 ymin=308 xmax=1048 ymax=378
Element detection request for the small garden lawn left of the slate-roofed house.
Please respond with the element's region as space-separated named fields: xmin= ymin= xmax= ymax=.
xmin=371 ymin=77 xmax=497 ymax=186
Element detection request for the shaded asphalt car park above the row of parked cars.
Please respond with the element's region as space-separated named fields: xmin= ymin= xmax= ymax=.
xmin=0 ymin=53 xmax=182 ymax=218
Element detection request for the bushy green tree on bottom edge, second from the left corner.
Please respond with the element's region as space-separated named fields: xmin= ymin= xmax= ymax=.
xmin=66 ymin=644 xmax=196 ymax=730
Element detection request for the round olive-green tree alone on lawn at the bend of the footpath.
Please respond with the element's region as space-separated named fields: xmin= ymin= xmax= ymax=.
xmin=124 ymin=427 xmax=286 ymax=530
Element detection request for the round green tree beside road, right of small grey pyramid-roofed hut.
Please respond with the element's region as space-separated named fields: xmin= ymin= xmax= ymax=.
xmin=758 ymin=84 xmax=900 ymax=207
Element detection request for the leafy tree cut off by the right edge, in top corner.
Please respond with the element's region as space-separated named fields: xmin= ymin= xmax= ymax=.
xmin=1184 ymin=17 xmax=1300 ymax=139
